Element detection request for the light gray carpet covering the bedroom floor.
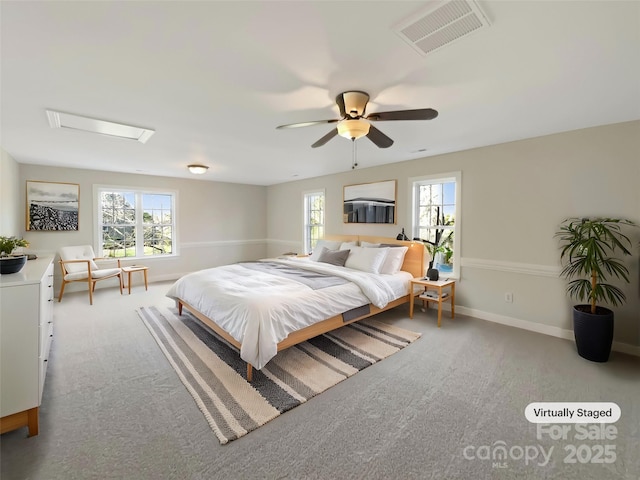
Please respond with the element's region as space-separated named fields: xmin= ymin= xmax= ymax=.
xmin=0 ymin=284 xmax=640 ymax=480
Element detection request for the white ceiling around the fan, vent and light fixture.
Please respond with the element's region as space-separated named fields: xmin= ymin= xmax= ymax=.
xmin=0 ymin=0 xmax=640 ymax=185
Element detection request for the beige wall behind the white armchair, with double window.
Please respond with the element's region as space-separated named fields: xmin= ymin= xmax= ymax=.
xmin=12 ymin=164 xmax=266 ymax=292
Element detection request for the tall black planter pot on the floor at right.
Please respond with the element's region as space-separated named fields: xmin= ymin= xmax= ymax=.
xmin=573 ymin=305 xmax=613 ymax=362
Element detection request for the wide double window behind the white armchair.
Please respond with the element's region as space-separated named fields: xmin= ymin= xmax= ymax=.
xmin=96 ymin=186 xmax=176 ymax=258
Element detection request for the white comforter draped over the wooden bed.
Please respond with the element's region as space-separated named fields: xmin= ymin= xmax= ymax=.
xmin=167 ymin=259 xmax=412 ymax=369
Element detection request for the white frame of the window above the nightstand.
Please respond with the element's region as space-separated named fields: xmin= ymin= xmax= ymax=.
xmin=409 ymin=171 xmax=462 ymax=279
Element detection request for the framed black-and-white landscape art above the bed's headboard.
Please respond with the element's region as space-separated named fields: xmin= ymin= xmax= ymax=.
xmin=342 ymin=180 xmax=397 ymax=224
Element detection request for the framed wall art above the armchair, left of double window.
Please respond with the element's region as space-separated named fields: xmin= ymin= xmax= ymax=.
xmin=27 ymin=180 xmax=80 ymax=231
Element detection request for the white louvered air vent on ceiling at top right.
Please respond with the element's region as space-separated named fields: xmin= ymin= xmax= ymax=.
xmin=393 ymin=0 xmax=489 ymax=55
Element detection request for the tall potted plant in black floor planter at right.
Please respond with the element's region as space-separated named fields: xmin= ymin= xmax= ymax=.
xmin=556 ymin=218 xmax=635 ymax=362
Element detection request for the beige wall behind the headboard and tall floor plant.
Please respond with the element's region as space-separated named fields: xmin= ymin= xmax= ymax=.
xmin=267 ymin=121 xmax=640 ymax=353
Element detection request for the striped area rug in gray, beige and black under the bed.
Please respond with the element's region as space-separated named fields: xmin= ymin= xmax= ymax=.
xmin=137 ymin=307 xmax=420 ymax=444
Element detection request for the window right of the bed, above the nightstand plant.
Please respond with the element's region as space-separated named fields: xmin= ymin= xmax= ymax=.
xmin=409 ymin=172 xmax=461 ymax=277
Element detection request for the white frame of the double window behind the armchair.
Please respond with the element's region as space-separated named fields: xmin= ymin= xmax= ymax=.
xmin=93 ymin=185 xmax=180 ymax=261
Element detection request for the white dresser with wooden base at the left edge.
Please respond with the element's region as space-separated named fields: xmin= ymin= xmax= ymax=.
xmin=0 ymin=257 xmax=53 ymax=436
